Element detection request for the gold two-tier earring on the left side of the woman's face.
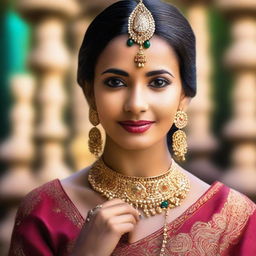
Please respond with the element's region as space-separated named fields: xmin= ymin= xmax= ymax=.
xmin=88 ymin=108 xmax=102 ymax=157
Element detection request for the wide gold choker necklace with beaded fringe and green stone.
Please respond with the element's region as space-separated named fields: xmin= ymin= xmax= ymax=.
xmin=88 ymin=158 xmax=190 ymax=217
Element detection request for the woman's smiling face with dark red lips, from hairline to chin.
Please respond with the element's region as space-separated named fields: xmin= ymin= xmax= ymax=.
xmin=94 ymin=35 xmax=187 ymax=150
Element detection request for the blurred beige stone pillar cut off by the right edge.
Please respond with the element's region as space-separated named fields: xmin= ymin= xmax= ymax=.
xmin=216 ymin=0 xmax=256 ymax=198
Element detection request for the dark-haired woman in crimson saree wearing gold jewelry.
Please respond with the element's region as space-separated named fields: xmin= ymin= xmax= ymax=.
xmin=9 ymin=0 xmax=256 ymax=256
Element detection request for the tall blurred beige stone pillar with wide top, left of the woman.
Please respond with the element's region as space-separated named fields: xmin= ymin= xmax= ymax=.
xmin=18 ymin=0 xmax=78 ymax=182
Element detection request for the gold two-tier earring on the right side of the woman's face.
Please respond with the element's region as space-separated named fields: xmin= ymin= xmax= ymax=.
xmin=172 ymin=110 xmax=188 ymax=161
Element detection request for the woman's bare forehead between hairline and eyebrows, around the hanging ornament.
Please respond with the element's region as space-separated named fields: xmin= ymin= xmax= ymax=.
xmin=95 ymin=35 xmax=179 ymax=75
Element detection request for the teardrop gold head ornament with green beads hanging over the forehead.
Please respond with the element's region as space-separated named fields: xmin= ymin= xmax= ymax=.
xmin=127 ymin=0 xmax=155 ymax=68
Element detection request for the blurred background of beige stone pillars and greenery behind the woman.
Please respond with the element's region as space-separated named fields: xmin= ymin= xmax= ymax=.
xmin=0 ymin=0 xmax=256 ymax=255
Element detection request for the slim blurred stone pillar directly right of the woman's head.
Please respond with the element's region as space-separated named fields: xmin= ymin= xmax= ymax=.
xmin=177 ymin=0 xmax=220 ymax=183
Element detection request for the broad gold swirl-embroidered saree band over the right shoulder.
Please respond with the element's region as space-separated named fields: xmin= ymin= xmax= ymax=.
xmin=167 ymin=190 xmax=255 ymax=256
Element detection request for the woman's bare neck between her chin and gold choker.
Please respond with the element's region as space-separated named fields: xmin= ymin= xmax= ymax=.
xmin=102 ymin=137 xmax=172 ymax=177
